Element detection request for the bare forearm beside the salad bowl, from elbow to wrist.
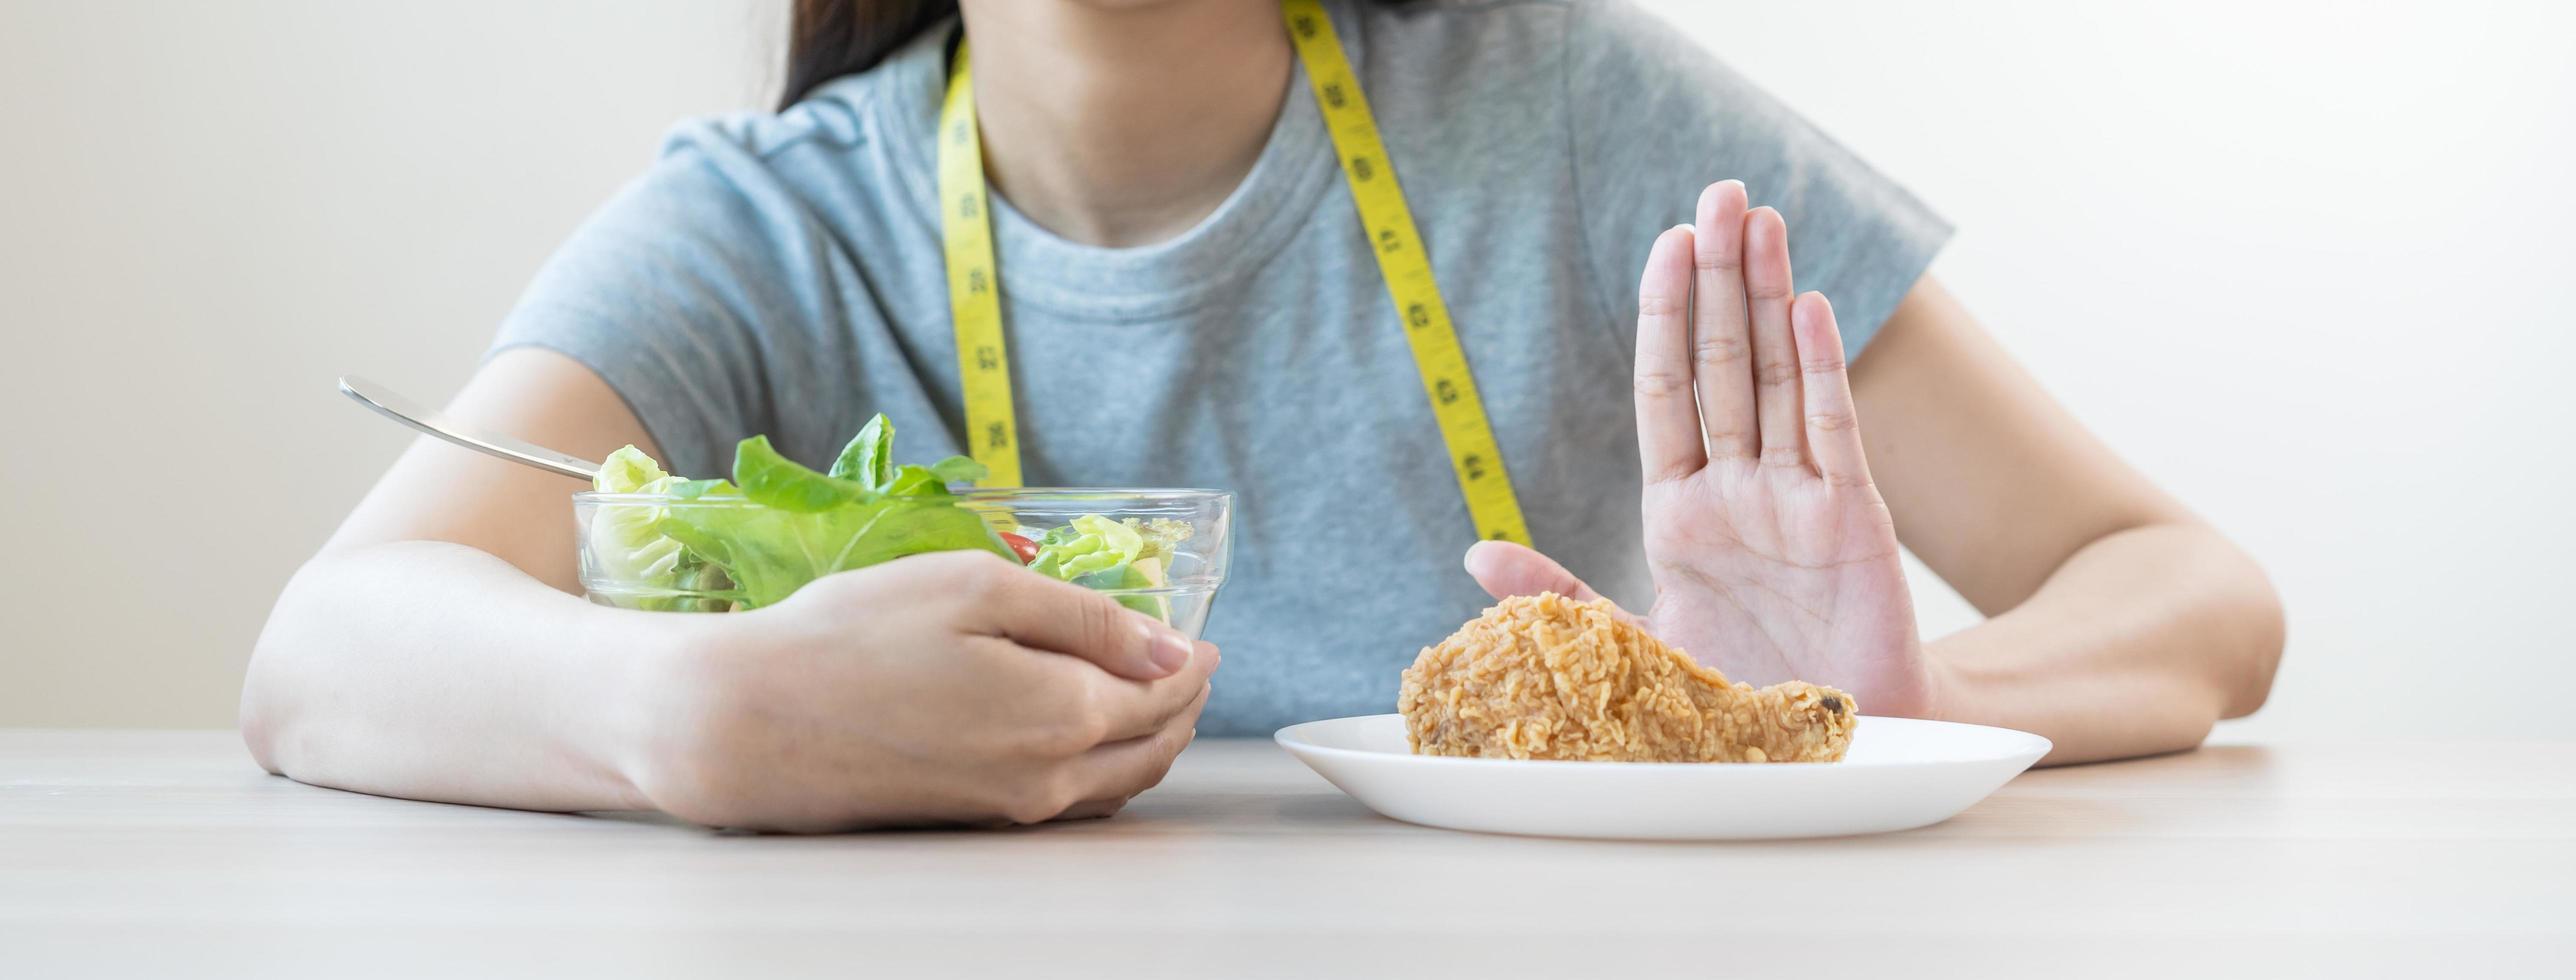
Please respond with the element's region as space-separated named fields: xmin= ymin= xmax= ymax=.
xmin=242 ymin=542 xmax=667 ymax=810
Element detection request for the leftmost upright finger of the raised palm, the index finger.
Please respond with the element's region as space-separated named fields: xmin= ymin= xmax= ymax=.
xmin=1636 ymin=224 xmax=1708 ymax=482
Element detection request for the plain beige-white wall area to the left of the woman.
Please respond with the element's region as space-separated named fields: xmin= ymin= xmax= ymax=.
xmin=0 ymin=0 xmax=783 ymax=725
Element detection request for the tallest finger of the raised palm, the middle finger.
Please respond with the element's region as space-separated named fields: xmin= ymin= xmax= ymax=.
xmin=1690 ymin=181 xmax=1759 ymax=459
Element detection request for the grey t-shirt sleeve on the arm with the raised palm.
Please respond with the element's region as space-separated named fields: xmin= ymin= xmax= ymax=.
xmin=1566 ymin=0 xmax=1950 ymax=353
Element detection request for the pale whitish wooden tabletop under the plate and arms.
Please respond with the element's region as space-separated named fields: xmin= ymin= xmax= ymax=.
xmin=0 ymin=730 xmax=2576 ymax=977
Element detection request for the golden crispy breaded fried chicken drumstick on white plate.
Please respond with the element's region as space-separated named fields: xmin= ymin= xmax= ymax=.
xmin=1396 ymin=593 xmax=1860 ymax=763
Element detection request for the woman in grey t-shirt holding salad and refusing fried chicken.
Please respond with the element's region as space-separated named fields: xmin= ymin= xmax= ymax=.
xmin=242 ymin=0 xmax=2282 ymax=830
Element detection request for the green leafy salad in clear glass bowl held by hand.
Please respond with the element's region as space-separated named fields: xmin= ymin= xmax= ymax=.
xmin=572 ymin=415 xmax=1234 ymax=640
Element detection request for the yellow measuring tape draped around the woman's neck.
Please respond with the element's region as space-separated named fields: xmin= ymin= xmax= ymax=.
xmin=940 ymin=0 xmax=1530 ymax=544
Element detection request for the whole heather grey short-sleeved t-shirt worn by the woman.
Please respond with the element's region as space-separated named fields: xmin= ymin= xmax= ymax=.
xmin=497 ymin=0 xmax=1947 ymax=735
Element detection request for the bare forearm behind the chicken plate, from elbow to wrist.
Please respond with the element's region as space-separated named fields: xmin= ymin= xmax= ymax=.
xmin=1929 ymin=524 xmax=2282 ymax=763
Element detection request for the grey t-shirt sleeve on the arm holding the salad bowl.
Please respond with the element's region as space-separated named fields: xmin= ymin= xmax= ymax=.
xmin=492 ymin=137 xmax=801 ymax=477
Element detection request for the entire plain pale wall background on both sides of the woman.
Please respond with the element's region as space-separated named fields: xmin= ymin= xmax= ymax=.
xmin=0 ymin=0 xmax=2576 ymax=738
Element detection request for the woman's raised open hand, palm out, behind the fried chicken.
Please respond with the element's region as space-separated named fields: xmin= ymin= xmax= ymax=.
xmin=1466 ymin=181 xmax=1932 ymax=714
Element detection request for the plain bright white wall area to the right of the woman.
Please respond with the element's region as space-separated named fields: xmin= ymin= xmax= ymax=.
xmin=1659 ymin=0 xmax=2576 ymax=738
